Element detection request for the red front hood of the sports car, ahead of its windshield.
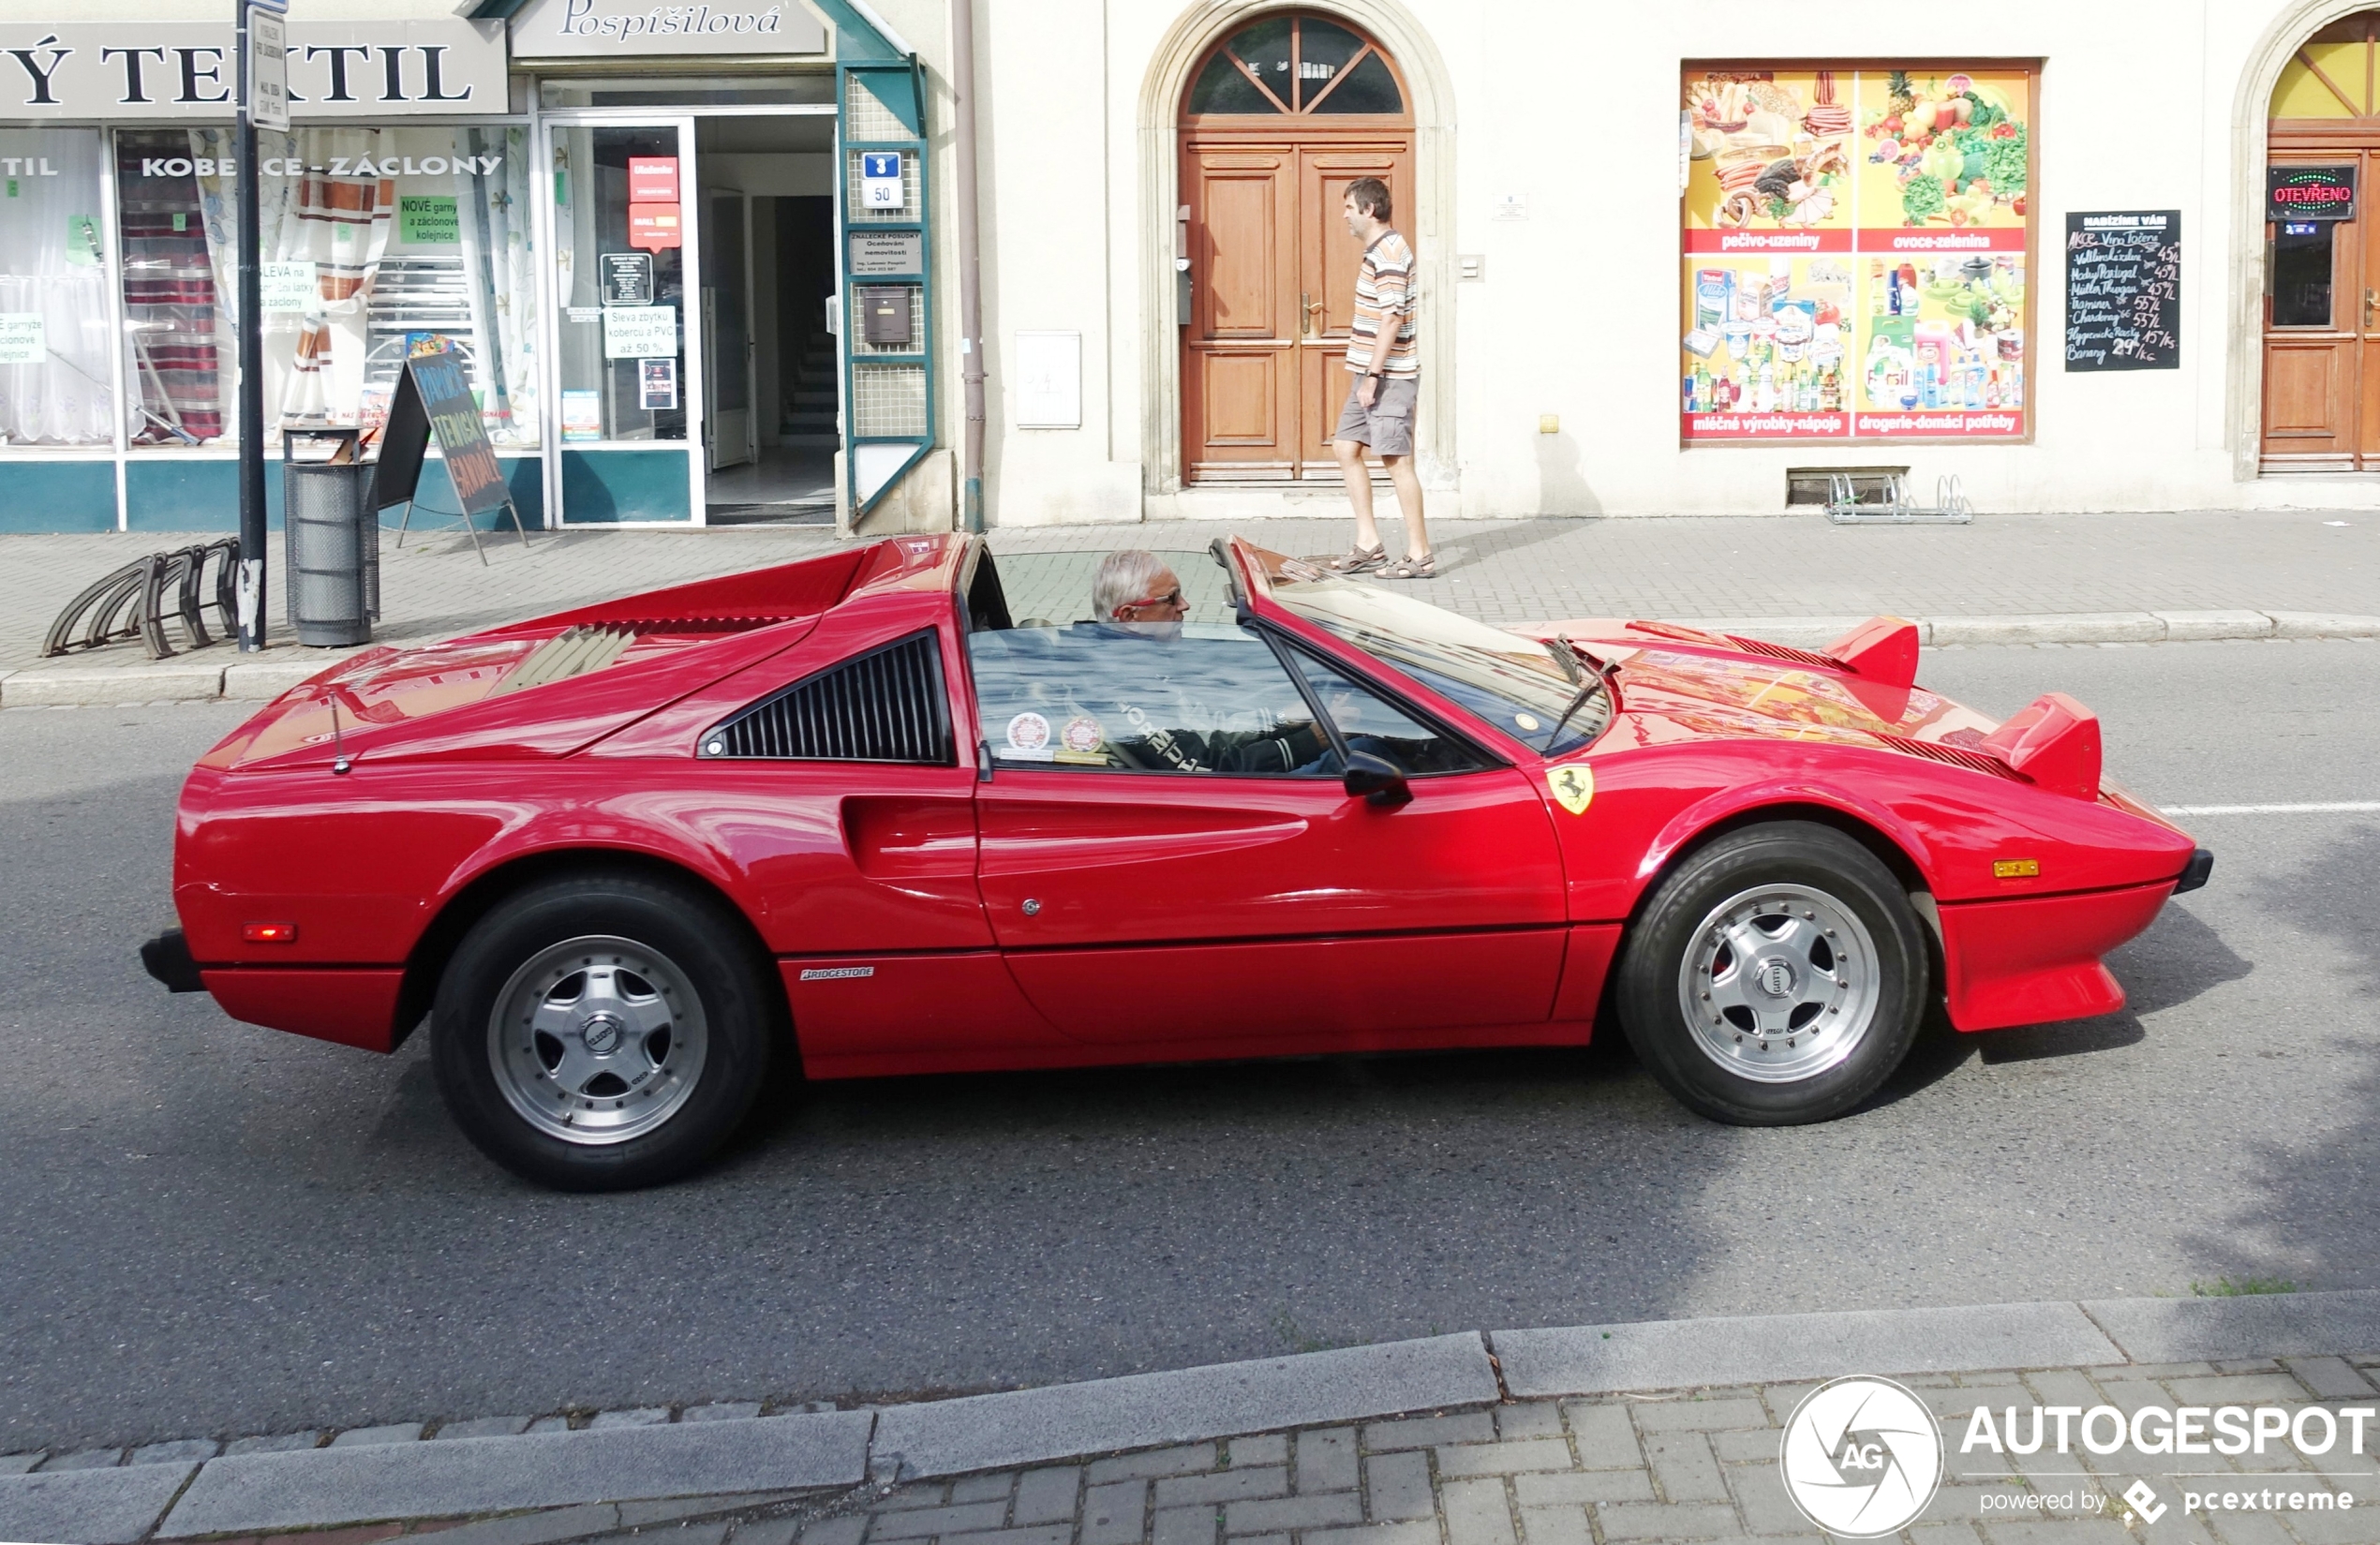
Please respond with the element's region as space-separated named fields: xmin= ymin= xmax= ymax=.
xmin=1516 ymin=617 xmax=2000 ymax=754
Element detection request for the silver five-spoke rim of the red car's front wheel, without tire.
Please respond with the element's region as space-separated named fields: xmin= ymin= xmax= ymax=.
xmin=1678 ymin=884 xmax=1882 ymax=1083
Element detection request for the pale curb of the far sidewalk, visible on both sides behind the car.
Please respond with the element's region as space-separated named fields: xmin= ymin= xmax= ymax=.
xmin=0 ymin=612 xmax=2380 ymax=707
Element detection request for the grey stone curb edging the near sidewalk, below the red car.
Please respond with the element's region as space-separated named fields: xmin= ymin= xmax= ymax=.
xmin=0 ymin=1290 xmax=2380 ymax=1545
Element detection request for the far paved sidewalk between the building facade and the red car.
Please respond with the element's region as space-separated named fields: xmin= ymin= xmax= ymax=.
xmin=0 ymin=513 xmax=2380 ymax=705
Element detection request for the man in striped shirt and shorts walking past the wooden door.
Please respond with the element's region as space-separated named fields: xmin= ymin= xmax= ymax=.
xmin=1331 ymin=176 xmax=1437 ymax=578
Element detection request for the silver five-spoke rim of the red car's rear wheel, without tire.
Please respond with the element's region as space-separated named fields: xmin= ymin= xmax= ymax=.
xmin=488 ymin=933 xmax=709 ymax=1148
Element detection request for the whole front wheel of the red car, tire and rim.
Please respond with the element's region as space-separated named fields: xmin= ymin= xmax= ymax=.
xmin=1616 ymin=822 xmax=1927 ymax=1126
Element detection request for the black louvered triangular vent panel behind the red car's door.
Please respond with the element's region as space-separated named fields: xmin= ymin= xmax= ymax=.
xmin=697 ymin=631 xmax=957 ymax=766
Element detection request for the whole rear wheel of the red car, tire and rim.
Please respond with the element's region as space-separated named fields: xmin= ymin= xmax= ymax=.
xmin=431 ymin=873 xmax=776 ymax=1190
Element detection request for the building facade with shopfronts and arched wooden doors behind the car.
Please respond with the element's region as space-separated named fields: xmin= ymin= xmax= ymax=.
xmin=0 ymin=0 xmax=2380 ymax=531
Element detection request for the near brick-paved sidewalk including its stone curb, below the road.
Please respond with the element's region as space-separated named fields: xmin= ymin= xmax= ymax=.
xmin=0 ymin=1290 xmax=2380 ymax=1545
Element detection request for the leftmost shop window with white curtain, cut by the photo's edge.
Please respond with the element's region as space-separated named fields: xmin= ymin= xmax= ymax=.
xmin=0 ymin=128 xmax=116 ymax=445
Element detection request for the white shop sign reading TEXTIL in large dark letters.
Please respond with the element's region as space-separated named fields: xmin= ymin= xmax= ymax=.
xmin=0 ymin=20 xmax=507 ymax=122
